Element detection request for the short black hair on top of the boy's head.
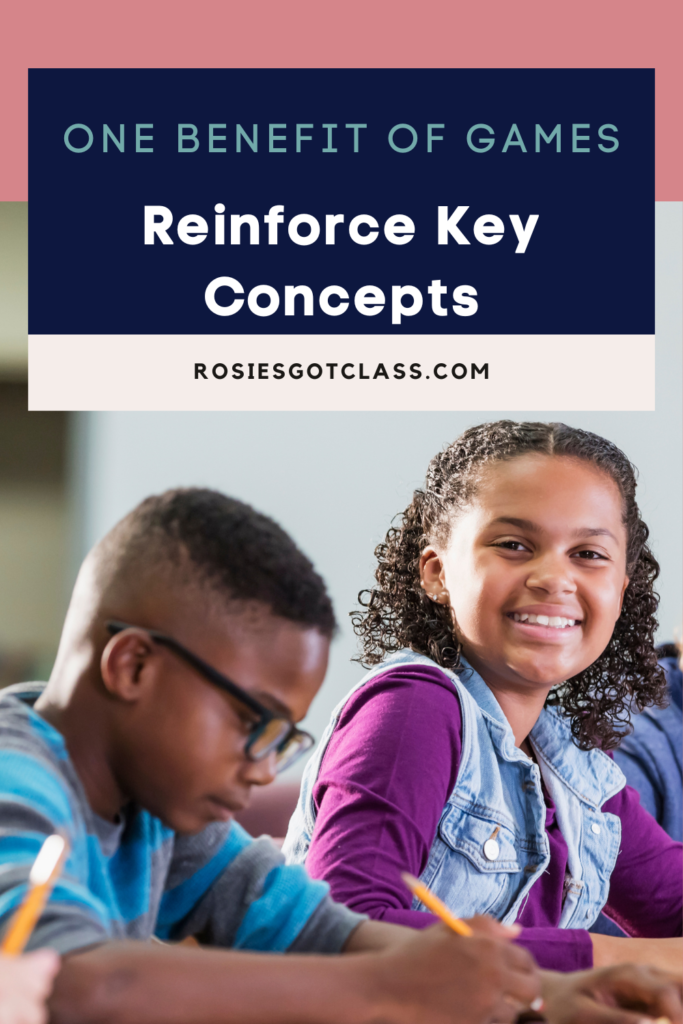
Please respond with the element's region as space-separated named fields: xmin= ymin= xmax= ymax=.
xmin=120 ymin=487 xmax=337 ymax=637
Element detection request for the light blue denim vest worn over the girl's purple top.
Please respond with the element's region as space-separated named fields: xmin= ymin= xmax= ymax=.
xmin=284 ymin=650 xmax=626 ymax=928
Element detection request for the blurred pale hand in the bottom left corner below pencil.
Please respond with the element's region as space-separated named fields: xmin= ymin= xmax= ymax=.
xmin=0 ymin=949 xmax=59 ymax=1024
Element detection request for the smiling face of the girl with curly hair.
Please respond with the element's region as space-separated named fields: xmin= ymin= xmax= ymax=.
xmin=421 ymin=455 xmax=629 ymax=692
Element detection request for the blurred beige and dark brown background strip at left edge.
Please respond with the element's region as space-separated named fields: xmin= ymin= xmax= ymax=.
xmin=0 ymin=203 xmax=70 ymax=685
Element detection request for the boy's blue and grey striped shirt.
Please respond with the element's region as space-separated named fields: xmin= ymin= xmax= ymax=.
xmin=0 ymin=683 xmax=366 ymax=953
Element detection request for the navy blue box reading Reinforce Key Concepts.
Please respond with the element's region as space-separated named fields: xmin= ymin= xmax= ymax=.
xmin=29 ymin=70 xmax=654 ymax=334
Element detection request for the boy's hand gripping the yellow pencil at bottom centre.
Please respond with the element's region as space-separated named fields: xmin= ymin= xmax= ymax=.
xmin=371 ymin=921 xmax=541 ymax=1024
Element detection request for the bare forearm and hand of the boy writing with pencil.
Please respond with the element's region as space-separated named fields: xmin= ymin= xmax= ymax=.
xmin=49 ymin=925 xmax=540 ymax=1024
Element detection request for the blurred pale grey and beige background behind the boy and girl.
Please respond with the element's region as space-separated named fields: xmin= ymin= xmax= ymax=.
xmin=0 ymin=203 xmax=683 ymax=781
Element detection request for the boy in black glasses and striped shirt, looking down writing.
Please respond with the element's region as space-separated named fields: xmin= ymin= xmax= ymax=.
xmin=0 ymin=489 xmax=680 ymax=1024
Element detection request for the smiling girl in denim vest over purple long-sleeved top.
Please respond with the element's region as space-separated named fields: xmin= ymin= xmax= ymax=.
xmin=285 ymin=421 xmax=682 ymax=971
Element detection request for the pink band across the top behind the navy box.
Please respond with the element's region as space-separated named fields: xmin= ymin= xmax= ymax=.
xmin=0 ymin=0 xmax=683 ymax=201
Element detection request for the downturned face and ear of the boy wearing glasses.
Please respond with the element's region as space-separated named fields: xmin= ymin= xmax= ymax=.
xmin=102 ymin=609 xmax=330 ymax=833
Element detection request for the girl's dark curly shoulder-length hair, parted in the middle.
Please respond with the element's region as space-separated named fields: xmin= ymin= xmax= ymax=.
xmin=352 ymin=420 xmax=666 ymax=750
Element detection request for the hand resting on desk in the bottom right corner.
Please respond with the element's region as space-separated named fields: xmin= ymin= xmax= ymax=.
xmin=543 ymin=964 xmax=682 ymax=1024
